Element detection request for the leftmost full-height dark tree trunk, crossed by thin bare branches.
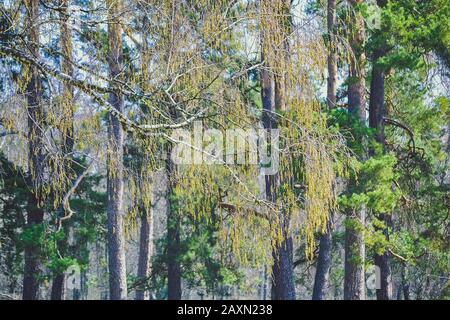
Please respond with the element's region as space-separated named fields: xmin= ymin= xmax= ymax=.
xmin=22 ymin=0 xmax=44 ymax=300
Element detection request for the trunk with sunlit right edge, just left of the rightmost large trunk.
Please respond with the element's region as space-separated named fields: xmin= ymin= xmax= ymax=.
xmin=344 ymin=0 xmax=366 ymax=300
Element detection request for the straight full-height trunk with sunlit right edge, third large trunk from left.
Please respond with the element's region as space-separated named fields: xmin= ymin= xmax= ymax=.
xmin=107 ymin=0 xmax=127 ymax=300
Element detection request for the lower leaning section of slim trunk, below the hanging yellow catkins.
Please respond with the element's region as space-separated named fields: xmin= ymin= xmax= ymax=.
xmin=312 ymin=214 xmax=333 ymax=300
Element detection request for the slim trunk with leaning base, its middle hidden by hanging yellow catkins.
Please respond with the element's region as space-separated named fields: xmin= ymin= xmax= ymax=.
xmin=312 ymin=0 xmax=337 ymax=300
